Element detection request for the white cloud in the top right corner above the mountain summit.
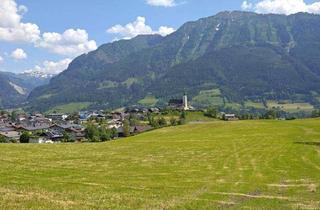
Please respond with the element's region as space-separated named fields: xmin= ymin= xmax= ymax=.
xmin=242 ymin=0 xmax=320 ymax=15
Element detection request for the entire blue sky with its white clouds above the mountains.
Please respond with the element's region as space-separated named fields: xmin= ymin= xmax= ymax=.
xmin=0 ymin=0 xmax=320 ymax=73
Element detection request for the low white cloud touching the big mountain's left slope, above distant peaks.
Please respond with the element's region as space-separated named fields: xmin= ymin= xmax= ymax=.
xmin=24 ymin=58 xmax=72 ymax=77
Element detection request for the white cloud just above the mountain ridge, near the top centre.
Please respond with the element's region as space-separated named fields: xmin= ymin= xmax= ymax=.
xmin=107 ymin=16 xmax=175 ymax=39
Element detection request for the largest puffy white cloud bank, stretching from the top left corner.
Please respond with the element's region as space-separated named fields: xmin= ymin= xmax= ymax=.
xmin=0 ymin=0 xmax=97 ymax=57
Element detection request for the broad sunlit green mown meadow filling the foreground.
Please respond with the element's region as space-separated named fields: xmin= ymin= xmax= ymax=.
xmin=0 ymin=119 xmax=320 ymax=209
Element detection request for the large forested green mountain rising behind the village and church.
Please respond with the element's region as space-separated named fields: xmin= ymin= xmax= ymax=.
xmin=28 ymin=12 xmax=320 ymax=110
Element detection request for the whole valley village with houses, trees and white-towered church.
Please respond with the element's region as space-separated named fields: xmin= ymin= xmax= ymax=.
xmin=0 ymin=95 xmax=238 ymax=144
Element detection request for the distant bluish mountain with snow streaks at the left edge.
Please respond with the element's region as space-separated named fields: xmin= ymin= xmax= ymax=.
xmin=0 ymin=72 xmax=49 ymax=108
